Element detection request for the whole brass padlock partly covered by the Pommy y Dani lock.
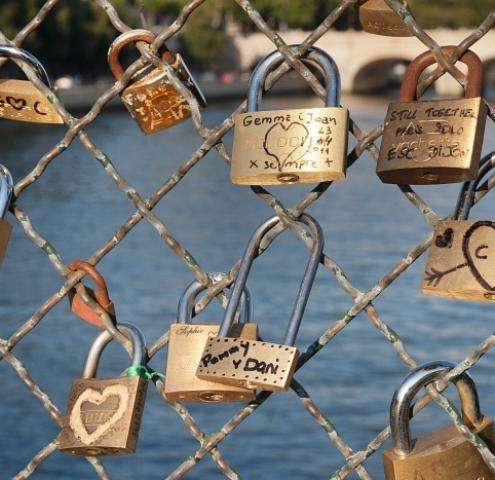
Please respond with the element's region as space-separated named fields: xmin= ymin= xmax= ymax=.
xmin=165 ymin=273 xmax=258 ymax=403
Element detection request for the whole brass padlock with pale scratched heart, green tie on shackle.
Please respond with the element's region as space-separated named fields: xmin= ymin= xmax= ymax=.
xmin=59 ymin=323 xmax=148 ymax=456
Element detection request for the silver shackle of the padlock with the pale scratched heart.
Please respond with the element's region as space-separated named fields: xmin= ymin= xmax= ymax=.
xmin=82 ymin=323 xmax=147 ymax=379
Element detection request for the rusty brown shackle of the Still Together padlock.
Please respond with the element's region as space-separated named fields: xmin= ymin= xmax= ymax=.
xmin=399 ymin=45 xmax=483 ymax=102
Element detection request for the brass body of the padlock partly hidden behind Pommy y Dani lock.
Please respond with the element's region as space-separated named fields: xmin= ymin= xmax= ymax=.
xmin=165 ymin=323 xmax=258 ymax=403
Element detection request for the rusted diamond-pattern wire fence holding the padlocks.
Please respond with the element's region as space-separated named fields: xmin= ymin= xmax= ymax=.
xmin=0 ymin=0 xmax=495 ymax=480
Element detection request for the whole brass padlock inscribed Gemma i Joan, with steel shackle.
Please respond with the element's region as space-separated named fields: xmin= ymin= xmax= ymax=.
xmin=230 ymin=45 xmax=349 ymax=185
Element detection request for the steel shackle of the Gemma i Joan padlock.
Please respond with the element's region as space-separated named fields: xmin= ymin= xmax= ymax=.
xmin=247 ymin=44 xmax=340 ymax=112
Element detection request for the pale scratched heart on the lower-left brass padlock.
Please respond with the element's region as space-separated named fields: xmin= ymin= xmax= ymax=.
xmin=69 ymin=385 xmax=129 ymax=445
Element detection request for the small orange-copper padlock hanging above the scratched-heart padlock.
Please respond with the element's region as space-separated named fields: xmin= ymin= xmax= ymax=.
xmin=68 ymin=260 xmax=116 ymax=328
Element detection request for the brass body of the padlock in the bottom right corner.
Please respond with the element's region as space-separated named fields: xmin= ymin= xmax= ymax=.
xmin=382 ymin=417 xmax=495 ymax=480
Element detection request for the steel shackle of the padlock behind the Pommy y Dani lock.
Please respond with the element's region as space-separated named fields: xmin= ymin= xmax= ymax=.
xmin=177 ymin=272 xmax=253 ymax=324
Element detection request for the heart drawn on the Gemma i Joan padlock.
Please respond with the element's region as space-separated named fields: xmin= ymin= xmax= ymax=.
xmin=263 ymin=122 xmax=309 ymax=172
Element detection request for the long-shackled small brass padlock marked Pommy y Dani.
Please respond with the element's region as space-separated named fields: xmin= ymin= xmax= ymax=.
xmin=196 ymin=214 xmax=324 ymax=392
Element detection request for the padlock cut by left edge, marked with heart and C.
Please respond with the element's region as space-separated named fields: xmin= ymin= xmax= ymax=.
xmin=0 ymin=45 xmax=64 ymax=124
